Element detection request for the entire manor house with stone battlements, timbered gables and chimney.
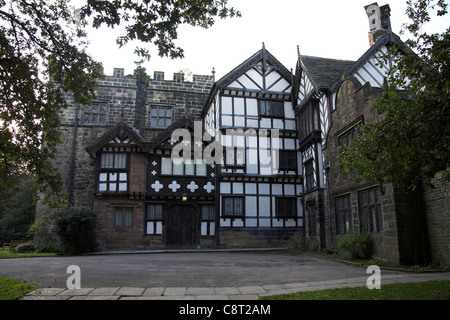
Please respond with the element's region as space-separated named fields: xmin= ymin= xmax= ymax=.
xmin=38 ymin=3 xmax=450 ymax=263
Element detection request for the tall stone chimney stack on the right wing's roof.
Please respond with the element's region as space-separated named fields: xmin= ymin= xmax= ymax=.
xmin=364 ymin=2 xmax=391 ymax=46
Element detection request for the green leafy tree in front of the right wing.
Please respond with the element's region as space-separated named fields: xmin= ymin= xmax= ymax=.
xmin=339 ymin=0 xmax=450 ymax=190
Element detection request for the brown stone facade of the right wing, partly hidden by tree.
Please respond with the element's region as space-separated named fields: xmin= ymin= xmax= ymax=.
xmin=323 ymin=78 xmax=399 ymax=263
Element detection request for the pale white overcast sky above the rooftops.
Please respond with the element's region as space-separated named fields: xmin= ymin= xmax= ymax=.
xmin=82 ymin=0 xmax=450 ymax=80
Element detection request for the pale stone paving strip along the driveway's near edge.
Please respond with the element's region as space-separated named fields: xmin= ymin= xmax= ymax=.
xmin=21 ymin=273 xmax=450 ymax=300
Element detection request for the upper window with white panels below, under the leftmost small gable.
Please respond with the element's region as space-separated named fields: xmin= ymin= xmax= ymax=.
xmin=98 ymin=153 xmax=129 ymax=192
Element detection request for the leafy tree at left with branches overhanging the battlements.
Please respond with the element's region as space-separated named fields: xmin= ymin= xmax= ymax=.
xmin=0 ymin=0 xmax=239 ymax=204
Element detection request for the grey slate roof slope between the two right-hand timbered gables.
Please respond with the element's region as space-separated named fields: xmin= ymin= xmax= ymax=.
xmin=299 ymin=55 xmax=355 ymax=91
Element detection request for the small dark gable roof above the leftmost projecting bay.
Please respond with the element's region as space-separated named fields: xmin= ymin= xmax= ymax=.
xmin=86 ymin=119 xmax=147 ymax=157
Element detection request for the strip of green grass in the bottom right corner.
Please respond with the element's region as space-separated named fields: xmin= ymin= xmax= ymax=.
xmin=261 ymin=281 xmax=450 ymax=300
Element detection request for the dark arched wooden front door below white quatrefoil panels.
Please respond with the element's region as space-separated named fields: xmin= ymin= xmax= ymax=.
xmin=166 ymin=205 xmax=199 ymax=247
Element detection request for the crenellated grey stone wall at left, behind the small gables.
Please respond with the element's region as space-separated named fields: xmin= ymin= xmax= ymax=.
xmin=50 ymin=69 xmax=214 ymax=210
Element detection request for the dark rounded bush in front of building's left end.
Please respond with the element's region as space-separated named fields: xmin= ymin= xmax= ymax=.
xmin=53 ymin=207 xmax=98 ymax=255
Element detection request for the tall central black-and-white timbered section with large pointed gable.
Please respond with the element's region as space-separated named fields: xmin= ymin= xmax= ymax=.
xmin=202 ymin=45 xmax=303 ymax=246
